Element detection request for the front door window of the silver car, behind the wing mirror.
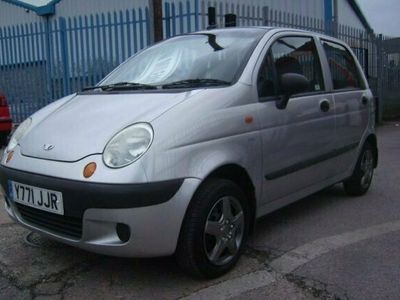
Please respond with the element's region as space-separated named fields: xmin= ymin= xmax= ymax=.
xmin=257 ymin=37 xmax=325 ymax=97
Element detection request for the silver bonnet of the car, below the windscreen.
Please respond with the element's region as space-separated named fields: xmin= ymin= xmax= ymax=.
xmin=20 ymin=90 xmax=201 ymax=162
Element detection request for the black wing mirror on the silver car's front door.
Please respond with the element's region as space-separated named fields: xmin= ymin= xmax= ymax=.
xmin=276 ymin=73 xmax=310 ymax=109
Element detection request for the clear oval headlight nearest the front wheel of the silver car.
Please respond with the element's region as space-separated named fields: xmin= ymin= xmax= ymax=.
xmin=103 ymin=123 xmax=153 ymax=168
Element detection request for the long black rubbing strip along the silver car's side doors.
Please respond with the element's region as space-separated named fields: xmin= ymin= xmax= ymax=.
xmin=265 ymin=142 xmax=360 ymax=180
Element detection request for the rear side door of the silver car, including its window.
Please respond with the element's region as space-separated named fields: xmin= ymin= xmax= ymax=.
xmin=321 ymin=39 xmax=372 ymax=173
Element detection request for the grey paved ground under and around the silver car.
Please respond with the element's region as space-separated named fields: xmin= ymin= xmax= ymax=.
xmin=0 ymin=123 xmax=400 ymax=300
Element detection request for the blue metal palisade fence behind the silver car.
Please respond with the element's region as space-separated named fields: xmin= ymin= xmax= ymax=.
xmin=0 ymin=0 xmax=376 ymax=123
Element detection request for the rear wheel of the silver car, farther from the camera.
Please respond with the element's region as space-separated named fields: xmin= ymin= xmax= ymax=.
xmin=343 ymin=143 xmax=375 ymax=196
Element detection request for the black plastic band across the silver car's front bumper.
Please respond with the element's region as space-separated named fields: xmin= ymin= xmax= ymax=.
xmin=0 ymin=166 xmax=183 ymax=218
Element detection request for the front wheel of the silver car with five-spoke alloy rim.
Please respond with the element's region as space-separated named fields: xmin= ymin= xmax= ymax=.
xmin=176 ymin=179 xmax=250 ymax=278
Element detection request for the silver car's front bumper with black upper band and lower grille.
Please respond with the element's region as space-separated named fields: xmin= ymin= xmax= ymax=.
xmin=0 ymin=166 xmax=200 ymax=257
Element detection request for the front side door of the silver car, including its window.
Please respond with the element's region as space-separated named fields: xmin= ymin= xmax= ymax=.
xmin=257 ymin=33 xmax=335 ymax=203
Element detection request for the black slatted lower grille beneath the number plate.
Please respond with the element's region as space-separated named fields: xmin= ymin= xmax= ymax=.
xmin=16 ymin=203 xmax=82 ymax=239
